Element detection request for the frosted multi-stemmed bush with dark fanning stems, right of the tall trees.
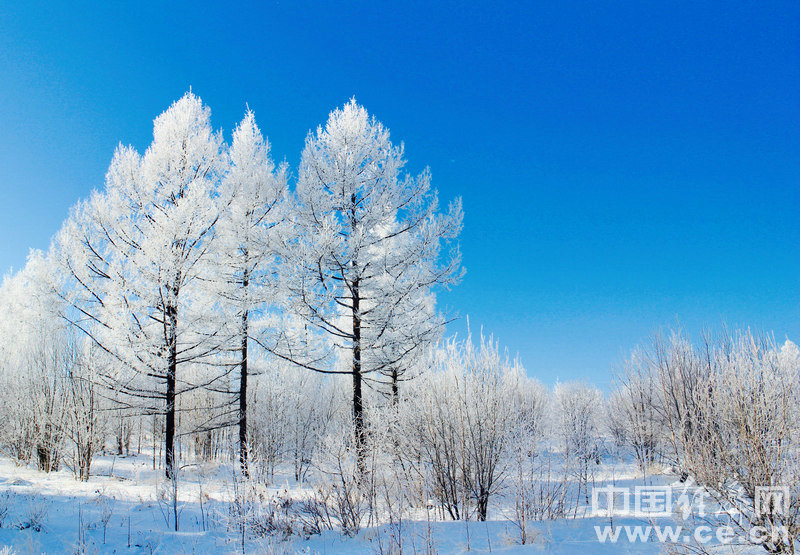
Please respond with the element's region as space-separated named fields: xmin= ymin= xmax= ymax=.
xmin=399 ymin=337 xmax=520 ymax=520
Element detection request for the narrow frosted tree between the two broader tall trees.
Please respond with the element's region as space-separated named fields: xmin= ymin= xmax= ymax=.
xmin=215 ymin=110 xmax=286 ymax=474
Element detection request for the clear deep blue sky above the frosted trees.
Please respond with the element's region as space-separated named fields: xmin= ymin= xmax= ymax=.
xmin=0 ymin=1 xmax=800 ymax=385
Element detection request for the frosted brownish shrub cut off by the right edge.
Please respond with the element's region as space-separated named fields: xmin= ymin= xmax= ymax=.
xmin=678 ymin=331 xmax=800 ymax=553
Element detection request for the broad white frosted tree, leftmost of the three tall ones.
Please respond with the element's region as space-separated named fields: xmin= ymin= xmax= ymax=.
xmin=57 ymin=93 xmax=225 ymax=482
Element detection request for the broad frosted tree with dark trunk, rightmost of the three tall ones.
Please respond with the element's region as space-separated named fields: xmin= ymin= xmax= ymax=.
xmin=276 ymin=100 xmax=462 ymax=459
